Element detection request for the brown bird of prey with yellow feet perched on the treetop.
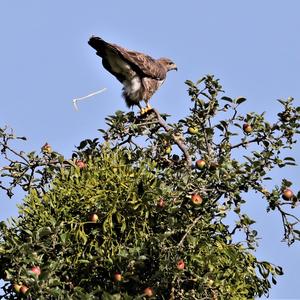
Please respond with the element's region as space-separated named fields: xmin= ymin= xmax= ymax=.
xmin=88 ymin=36 xmax=177 ymax=113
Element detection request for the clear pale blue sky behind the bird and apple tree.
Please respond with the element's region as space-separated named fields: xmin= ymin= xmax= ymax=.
xmin=0 ymin=0 xmax=300 ymax=299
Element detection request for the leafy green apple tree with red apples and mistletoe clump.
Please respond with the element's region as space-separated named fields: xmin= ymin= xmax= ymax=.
xmin=0 ymin=76 xmax=300 ymax=299
